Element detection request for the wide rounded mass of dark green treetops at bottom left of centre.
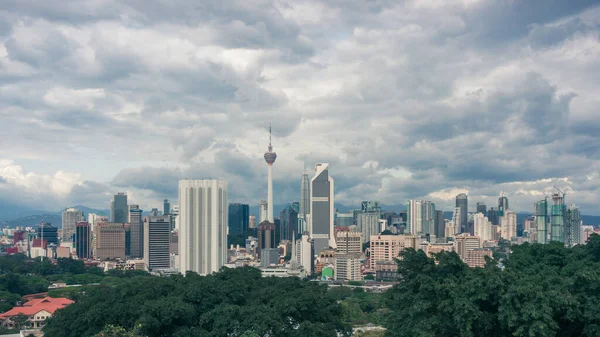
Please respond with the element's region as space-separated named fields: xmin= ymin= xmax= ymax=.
xmin=44 ymin=268 xmax=350 ymax=337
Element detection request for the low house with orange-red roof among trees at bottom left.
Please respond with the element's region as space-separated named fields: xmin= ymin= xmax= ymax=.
xmin=0 ymin=297 xmax=74 ymax=329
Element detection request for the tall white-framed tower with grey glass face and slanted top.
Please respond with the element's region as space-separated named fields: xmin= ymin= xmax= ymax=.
xmin=309 ymin=163 xmax=335 ymax=253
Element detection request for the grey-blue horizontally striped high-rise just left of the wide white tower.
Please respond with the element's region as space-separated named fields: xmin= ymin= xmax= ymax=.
xmin=144 ymin=215 xmax=171 ymax=270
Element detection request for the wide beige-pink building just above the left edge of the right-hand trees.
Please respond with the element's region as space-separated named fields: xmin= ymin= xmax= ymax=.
xmin=369 ymin=235 xmax=420 ymax=270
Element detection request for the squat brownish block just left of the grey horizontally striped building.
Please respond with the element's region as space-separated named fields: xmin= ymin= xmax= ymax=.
xmin=96 ymin=223 xmax=126 ymax=260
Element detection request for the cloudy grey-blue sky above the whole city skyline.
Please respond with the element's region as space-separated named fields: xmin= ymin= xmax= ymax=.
xmin=0 ymin=0 xmax=600 ymax=215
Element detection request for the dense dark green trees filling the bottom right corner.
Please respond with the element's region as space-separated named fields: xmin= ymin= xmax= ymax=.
xmin=385 ymin=236 xmax=600 ymax=337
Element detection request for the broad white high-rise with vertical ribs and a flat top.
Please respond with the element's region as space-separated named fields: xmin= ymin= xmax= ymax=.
xmin=179 ymin=180 xmax=228 ymax=275
